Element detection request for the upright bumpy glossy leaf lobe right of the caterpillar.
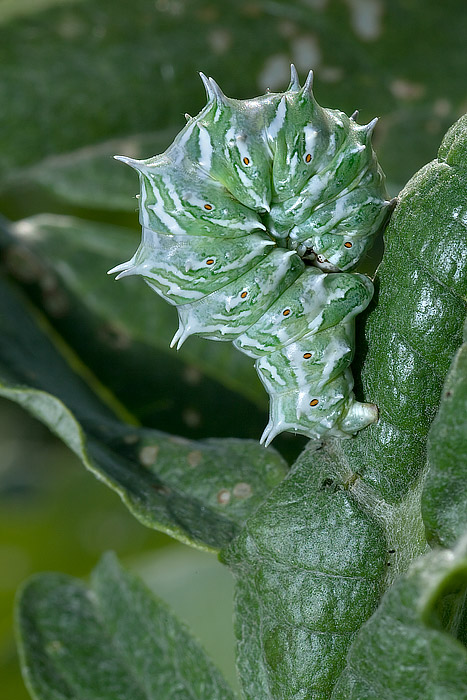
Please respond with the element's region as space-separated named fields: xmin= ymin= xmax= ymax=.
xmin=310 ymin=115 xmax=467 ymax=504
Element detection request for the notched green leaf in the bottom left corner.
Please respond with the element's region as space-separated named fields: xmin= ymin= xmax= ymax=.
xmin=17 ymin=554 xmax=238 ymax=700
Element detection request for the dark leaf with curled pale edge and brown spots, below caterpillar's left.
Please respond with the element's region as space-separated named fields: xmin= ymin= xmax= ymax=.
xmin=0 ymin=279 xmax=285 ymax=550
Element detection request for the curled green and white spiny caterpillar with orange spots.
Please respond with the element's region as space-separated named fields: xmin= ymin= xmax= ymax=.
xmin=111 ymin=66 xmax=391 ymax=445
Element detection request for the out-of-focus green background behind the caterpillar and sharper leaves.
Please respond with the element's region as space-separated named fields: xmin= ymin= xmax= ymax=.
xmin=0 ymin=0 xmax=467 ymax=700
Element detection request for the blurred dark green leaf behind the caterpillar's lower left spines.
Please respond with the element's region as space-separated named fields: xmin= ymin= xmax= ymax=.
xmin=5 ymin=215 xmax=267 ymax=437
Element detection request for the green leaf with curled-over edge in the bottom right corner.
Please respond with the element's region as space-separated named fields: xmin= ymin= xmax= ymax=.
xmin=332 ymin=538 xmax=467 ymax=700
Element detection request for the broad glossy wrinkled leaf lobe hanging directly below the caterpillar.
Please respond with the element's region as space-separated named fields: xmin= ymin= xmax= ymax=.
xmin=221 ymin=448 xmax=388 ymax=700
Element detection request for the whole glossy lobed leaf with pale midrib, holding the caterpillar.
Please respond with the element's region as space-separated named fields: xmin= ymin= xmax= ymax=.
xmin=224 ymin=118 xmax=467 ymax=700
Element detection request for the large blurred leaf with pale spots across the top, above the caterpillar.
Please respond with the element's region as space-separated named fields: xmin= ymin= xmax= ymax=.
xmin=0 ymin=0 xmax=467 ymax=191
